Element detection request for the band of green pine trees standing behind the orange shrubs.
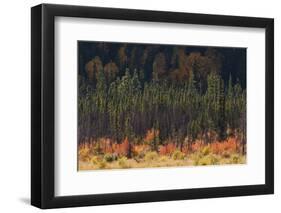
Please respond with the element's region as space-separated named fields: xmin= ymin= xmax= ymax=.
xmin=78 ymin=48 xmax=246 ymax=157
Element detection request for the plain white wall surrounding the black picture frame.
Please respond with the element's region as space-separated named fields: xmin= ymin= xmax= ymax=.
xmin=0 ymin=0 xmax=281 ymax=213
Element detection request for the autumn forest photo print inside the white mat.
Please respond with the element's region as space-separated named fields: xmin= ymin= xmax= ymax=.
xmin=77 ymin=41 xmax=247 ymax=171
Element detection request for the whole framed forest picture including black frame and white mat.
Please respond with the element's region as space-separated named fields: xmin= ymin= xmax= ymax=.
xmin=31 ymin=4 xmax=274 ymax=209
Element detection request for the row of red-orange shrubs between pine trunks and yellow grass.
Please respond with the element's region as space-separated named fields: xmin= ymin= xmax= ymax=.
xmin=78 ymin=136 xmax=241 ymax=161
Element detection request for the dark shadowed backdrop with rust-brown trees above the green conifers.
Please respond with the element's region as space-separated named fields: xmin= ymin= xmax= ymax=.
xmin=78 ymin=41 xmax=246 ymax=89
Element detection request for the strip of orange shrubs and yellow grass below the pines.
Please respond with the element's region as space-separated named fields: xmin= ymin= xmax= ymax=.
xmin=78 ymin=129 xmax=244 ymax=169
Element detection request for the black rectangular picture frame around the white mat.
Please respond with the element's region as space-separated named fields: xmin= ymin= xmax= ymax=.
xmin=31 ymin=4 xmax=274 ymax=209
